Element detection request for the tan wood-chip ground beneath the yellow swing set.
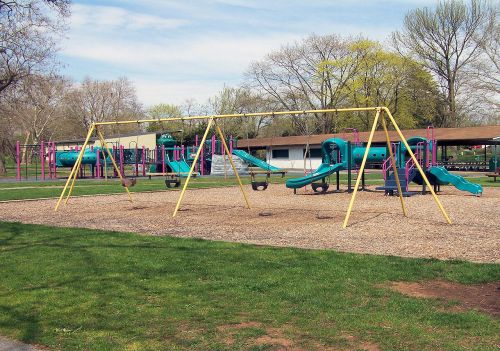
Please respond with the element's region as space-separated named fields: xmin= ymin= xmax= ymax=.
xmin=0 ymin=184 xmax=500 ymax=262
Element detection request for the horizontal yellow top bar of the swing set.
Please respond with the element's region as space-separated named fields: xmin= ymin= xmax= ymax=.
xmin=94 ymin=107 xmax=387 ymax=126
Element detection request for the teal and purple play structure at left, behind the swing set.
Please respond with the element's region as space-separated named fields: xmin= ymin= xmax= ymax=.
xmin=16 ymin=133 xmax=260 ymax=180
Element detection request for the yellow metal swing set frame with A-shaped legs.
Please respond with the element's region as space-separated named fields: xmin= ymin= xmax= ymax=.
xmin=54 ymin=106 xmax=451 ymax=228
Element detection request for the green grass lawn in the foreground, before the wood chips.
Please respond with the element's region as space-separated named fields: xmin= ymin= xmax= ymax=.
xmin=0 ymin=222 xmax=500 ymax=351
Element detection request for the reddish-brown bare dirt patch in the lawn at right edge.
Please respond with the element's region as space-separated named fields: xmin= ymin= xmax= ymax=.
xmin=390 ymin=280 xmax=500 ymax=317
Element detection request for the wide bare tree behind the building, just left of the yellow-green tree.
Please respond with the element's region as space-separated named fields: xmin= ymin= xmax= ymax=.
xmin=246 ymin=35 xmax=356 ymax=134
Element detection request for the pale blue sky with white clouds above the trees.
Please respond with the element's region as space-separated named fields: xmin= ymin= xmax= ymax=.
xmin=59 ymin=0 xmax=435 ymax=107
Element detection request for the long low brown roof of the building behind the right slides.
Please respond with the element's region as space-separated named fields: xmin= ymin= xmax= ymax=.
xmin=238 ymin=126 xmax=500 ymax=149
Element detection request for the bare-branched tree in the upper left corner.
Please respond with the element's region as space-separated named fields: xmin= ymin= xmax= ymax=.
xmin=0 ymin=0 xmax=69 ymax=174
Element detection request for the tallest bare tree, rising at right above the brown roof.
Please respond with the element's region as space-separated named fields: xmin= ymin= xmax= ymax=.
xmin=392 ymin=0 xmax=495 ymax=127
